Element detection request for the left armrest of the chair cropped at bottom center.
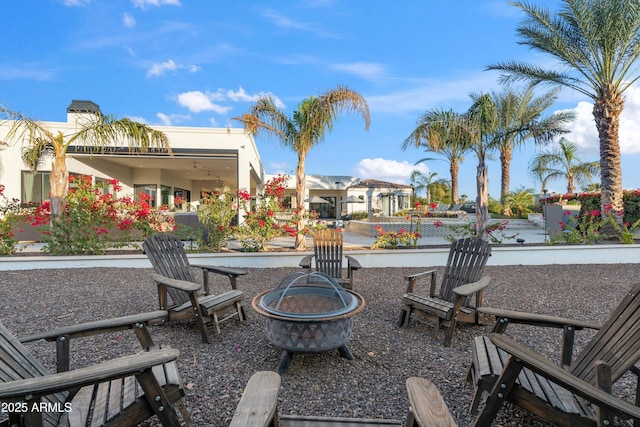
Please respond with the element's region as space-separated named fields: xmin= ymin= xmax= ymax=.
xmin=229 ymin=371 xmax=281 ymax=427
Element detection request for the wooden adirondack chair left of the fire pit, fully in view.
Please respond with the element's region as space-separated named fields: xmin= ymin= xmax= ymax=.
xmin=142 ymin=234 xmax=247 ymax=343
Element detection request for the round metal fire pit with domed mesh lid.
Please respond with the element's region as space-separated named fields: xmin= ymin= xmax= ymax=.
xmin=251 ymin=272 xmax=365 ymax=373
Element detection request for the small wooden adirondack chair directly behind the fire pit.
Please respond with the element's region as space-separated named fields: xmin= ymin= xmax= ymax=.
xmin=300 ymin=228 xmax=362 ymax=289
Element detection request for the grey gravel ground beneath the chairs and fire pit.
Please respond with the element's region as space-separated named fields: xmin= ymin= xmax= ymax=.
xmin=0 ymin=264 xmax=638 ymax=426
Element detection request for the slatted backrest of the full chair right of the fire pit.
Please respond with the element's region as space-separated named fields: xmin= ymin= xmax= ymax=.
xmin=439 ymin=237 xmax=491 ymax=306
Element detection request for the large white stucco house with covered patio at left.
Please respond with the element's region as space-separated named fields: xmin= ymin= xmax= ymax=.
xmin=0 ymin=101 xmax=264 ymax=214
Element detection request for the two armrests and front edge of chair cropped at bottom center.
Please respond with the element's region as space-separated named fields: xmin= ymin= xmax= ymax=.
xmin=230 ymin=371 xmax=456 ymax=427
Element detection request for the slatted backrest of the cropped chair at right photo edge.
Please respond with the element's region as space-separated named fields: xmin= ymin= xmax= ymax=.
xmin=570 ymin=283 xmax=640 ymax=385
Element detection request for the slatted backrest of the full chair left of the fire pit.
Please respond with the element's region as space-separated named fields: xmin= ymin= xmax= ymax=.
xmin=142 ymin=234 xmax=195 ymax=305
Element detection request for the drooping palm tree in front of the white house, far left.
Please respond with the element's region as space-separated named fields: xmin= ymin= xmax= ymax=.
xmin=0 ymin=106 xmax=172 ymax=219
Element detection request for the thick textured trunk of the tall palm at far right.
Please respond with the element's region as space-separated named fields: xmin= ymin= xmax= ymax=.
xmin=593 ymin=87 xmax=624 ymax=235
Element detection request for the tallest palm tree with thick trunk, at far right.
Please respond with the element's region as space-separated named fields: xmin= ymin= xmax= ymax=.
xmin=487 ymin=0 xmax=640 ymax=229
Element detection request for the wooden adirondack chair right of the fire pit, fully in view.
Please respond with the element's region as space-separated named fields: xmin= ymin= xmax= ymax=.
xmin=398 ymin=237 xmax=491 ymax=346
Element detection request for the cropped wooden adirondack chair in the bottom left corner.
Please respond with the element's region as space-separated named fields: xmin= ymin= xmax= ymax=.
xmin=0 ymin=311 xmax=191 ymax=427
